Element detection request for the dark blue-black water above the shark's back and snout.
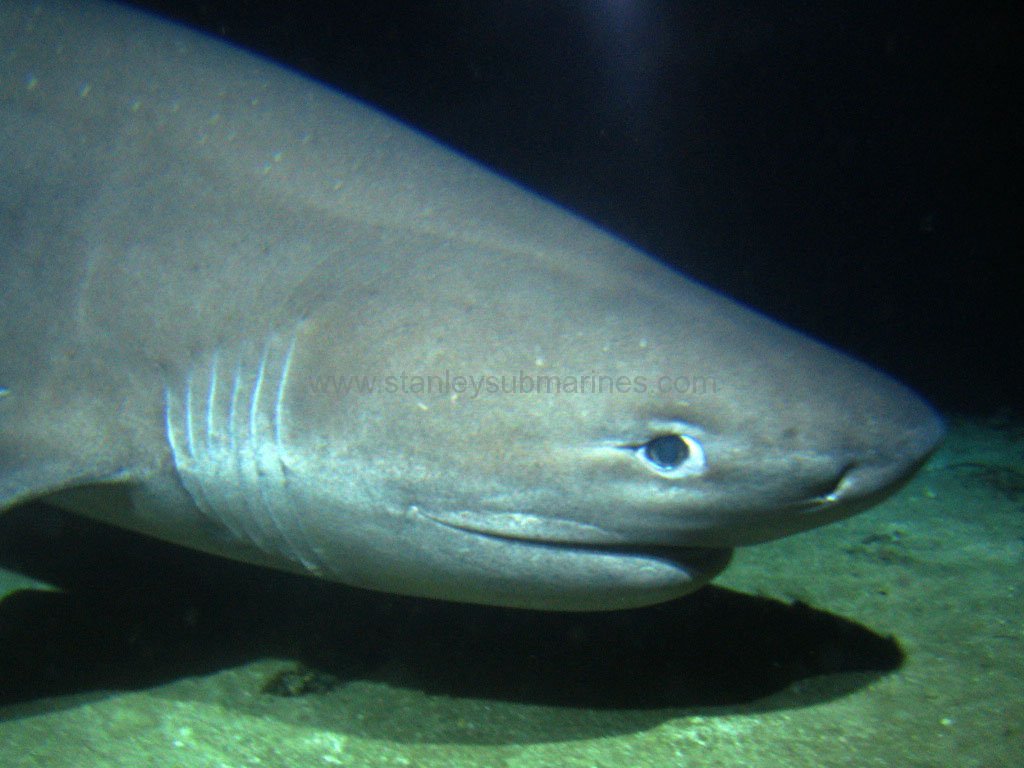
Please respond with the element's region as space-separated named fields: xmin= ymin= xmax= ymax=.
xmin=133 ymin=0 xmax=1024 ymax=415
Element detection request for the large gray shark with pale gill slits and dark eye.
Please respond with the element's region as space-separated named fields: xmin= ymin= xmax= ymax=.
xmin=0 ymin=0 xmax=942 ymax=610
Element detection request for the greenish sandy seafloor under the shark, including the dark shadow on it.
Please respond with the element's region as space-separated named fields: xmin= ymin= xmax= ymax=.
xmin=0 ymin=418 xmax=1024 ymax=768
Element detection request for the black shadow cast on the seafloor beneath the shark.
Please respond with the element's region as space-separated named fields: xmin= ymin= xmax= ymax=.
xmin=0 ymin=506 xmax=902 ymax=739
